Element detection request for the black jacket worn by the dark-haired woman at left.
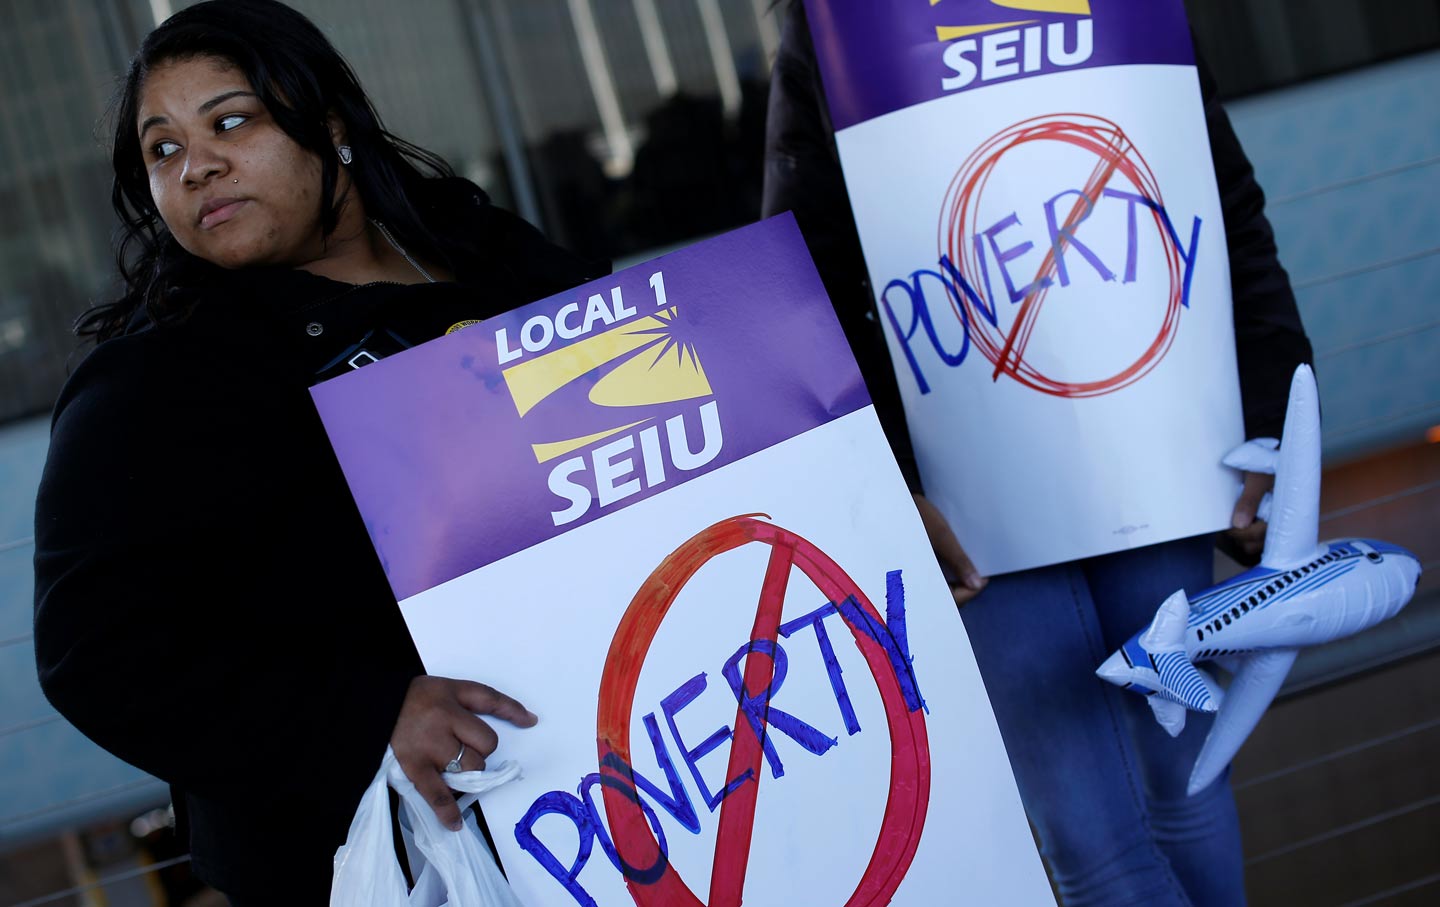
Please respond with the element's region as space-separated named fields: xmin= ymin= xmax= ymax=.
xmin=35 ymin=180 xmax=602 ymax=904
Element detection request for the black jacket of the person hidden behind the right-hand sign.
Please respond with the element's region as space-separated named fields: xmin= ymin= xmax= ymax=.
xmin=763 ymin=0 xmax=1313 ymax=491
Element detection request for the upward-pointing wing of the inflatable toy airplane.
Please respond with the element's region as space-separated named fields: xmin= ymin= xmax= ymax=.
xmin=1260 ymin=366 xmax=1320 ymax=570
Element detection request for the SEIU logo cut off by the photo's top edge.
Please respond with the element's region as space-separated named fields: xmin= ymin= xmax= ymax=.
xmin=930 ymin=0 xmax=1094 ymax=91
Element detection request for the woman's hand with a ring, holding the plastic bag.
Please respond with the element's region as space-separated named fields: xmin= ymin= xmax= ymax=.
xmin=390 ymin=675 xmax=539 ymax=831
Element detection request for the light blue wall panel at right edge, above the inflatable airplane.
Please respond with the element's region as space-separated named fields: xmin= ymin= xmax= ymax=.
xmin=1230 ymin=53 xmax=1440 ymax=464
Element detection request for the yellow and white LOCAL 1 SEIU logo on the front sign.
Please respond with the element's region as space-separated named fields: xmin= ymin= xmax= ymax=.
xmin=495 ymin=271 xmax=724 ymax=525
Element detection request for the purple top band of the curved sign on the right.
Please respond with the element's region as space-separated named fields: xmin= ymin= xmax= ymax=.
xmin=805 ymin=0 xmax=1195 ymax=131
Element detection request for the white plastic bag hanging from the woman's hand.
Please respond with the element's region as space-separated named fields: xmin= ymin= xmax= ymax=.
xmin=330 ymin=747 xmax=521 ymax=907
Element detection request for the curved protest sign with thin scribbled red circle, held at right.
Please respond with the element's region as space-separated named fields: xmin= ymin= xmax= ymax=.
xmin=806 ymin=0 xmax=1244 ymax=574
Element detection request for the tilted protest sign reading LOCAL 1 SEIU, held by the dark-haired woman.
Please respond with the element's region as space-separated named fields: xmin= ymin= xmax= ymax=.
xmin=314 ymin=216 xmax=1053 ymax=907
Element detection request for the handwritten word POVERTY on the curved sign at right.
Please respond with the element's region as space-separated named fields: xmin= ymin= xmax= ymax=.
xmin=880 ymin=187 xmax=1201 ymax=394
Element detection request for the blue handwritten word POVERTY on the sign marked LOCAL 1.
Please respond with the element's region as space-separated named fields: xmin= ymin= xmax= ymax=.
xmin=516 ymin=570 xmax=924 ymax=907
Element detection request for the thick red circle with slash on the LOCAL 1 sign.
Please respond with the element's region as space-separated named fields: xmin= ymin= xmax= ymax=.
xmin=596 ymin=517 xmax=930 ymax=907
